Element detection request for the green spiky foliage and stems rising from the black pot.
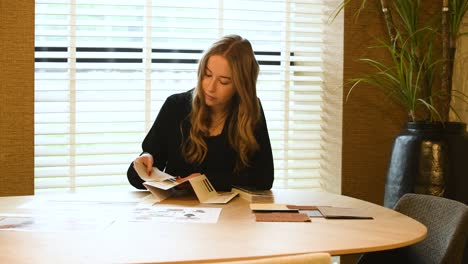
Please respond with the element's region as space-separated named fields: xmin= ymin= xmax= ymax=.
xmin=338 ymin=0 xmax=468 ymax=122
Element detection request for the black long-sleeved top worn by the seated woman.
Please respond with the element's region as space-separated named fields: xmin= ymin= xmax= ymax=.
xmin=127 ymin=90 xmax=274 ymax=191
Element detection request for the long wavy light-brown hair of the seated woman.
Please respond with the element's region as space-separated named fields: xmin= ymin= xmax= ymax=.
xmin=182 ymin=35 xmax=260 ymax=172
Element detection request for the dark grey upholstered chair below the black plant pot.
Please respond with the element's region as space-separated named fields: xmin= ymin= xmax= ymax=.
xmin=358 ymin=193 xmax=468 ymax=264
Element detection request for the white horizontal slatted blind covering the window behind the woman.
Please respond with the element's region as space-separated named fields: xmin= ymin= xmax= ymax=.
xmin=35 ymin=0 xmax=340 ymax=191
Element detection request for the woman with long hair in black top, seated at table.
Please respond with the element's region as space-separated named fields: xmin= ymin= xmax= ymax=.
xmin=127 ymin=35 xmax=274 ymax=191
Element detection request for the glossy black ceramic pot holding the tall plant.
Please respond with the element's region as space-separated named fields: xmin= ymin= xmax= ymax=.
xmin=384 ymin=122 xmax=468 ymax=208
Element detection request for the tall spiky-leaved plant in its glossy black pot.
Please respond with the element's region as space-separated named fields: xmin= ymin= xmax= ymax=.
xmin=338 ymin=0 xmax=468 ymax=207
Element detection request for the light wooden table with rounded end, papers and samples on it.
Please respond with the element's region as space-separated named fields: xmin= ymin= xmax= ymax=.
xmin=0 ymin=190 xmax=427 ymax=263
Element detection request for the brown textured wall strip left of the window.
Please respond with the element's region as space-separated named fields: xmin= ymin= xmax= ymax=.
xmin=0 ymin=0 xmax=34 ymax=196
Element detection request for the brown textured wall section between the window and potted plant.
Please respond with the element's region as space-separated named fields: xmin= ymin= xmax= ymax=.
xmin=341 ymin=1 xmax=405 ymax=204
